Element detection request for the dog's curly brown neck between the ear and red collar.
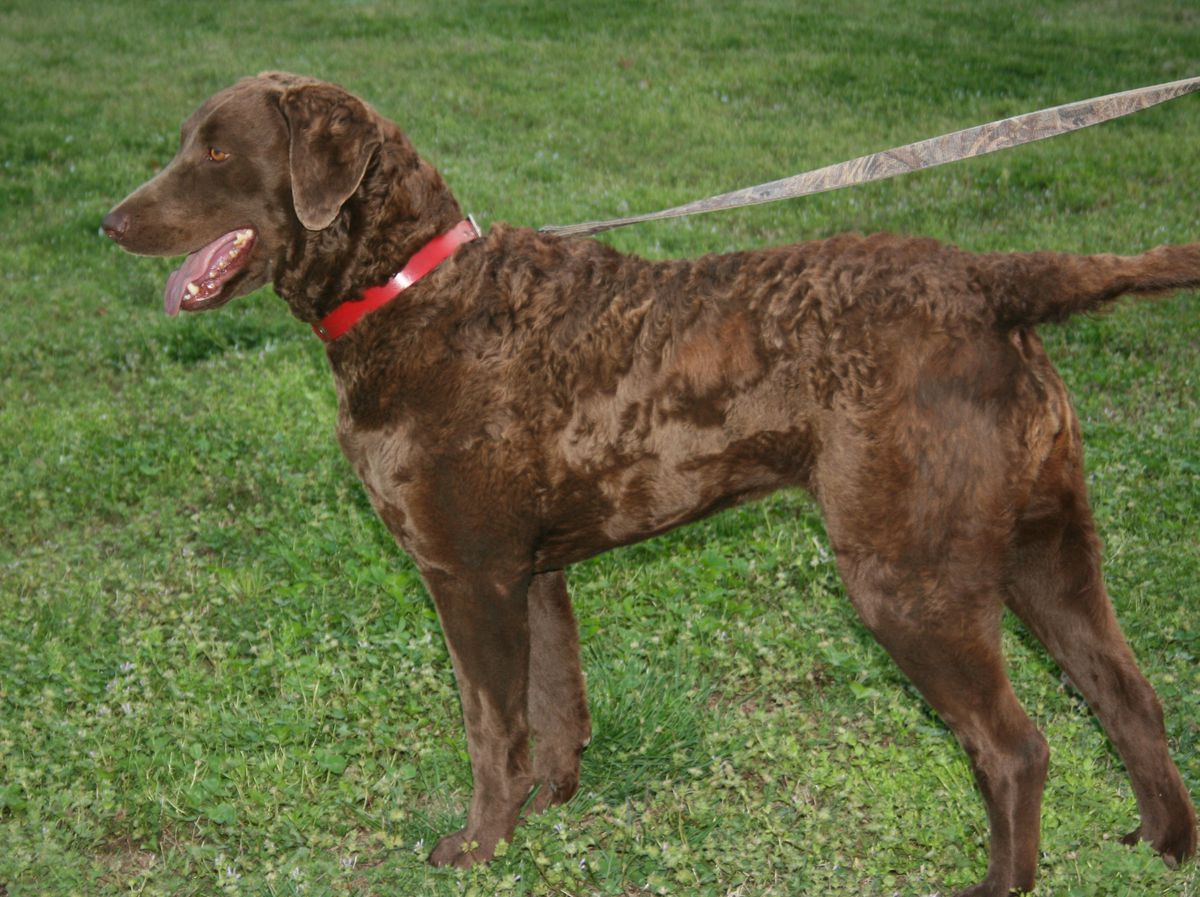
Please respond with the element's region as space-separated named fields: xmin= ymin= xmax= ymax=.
xmin=275 ymin=126 xmax=463 ymax=324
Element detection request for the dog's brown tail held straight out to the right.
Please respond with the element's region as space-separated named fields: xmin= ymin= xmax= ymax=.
xmin=976 ymin=243 xmax=1200 ymax=330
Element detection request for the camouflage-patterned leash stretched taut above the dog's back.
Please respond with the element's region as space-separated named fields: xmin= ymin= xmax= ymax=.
xmin=540 ymin=78 xmax=1200 ymax=236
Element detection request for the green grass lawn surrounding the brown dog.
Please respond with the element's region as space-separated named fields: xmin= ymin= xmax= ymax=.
xmin=0 ymin=0 xmax=1200 ymax=897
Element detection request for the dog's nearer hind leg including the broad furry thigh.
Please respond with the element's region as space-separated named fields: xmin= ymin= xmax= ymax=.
xmin=815 ymin=395 xmax=1049 ymax=897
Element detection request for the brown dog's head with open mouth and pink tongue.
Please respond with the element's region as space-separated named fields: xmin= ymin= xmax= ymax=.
xmin=103 ymin=72 xmax=382 ymax=314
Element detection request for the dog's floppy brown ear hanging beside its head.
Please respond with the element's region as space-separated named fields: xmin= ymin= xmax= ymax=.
xmin=280 ymin=83 xmax=382 ymax=230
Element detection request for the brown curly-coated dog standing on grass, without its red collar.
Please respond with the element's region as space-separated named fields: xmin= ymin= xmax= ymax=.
xmin=104 ymin=73 xmax=1200 ymax=895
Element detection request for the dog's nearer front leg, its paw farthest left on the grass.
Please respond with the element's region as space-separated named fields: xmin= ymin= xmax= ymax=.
xmin=425 ymin=570 xmax=534 ymax=868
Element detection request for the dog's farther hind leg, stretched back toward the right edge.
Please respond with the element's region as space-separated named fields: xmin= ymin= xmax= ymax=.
xmin=1007 ymin=425 xmax=1196 ymax=866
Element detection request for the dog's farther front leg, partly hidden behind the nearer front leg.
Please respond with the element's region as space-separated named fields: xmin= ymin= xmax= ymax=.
xmin=529 ymin=570 xmax=592 ymax=813
